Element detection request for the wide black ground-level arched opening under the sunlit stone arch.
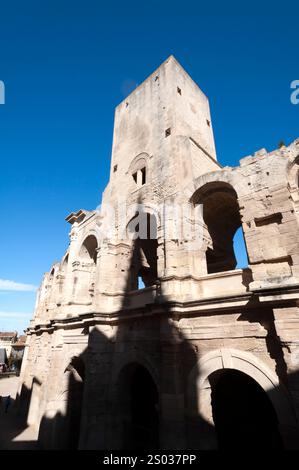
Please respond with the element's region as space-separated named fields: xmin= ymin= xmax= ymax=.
xmin=209 ymin=369 xmax=283 ymax=449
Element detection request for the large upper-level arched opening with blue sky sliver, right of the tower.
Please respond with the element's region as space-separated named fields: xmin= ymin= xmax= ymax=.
xmin=193 ymin=182 xmax=248 ymax=274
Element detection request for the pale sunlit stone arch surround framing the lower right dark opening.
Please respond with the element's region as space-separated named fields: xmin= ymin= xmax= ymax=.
xmin=187 ymin=348 xmax=298 ymax=445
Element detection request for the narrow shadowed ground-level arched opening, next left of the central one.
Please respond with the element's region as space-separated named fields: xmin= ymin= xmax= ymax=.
xmin=65 ymin=356 xmax=85 ymax=450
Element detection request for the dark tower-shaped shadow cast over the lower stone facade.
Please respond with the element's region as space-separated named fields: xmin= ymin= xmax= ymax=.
xmin=6 ymin=207 xmax=299 ymax=451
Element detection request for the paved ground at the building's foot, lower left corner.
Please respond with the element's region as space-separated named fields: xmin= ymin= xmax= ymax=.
xmin=0 ymin=377 xmax=37 ymax=450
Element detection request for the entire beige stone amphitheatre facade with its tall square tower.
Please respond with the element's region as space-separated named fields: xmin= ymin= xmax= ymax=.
xmin=18 ymin=56 xmax=299 ymax=450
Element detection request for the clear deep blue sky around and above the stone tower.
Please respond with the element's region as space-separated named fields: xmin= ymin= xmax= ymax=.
xmin=0 ymin=0 xmax=299 ymax=331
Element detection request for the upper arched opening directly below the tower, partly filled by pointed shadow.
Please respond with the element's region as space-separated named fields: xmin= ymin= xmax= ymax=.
xmin=128 ymin=212 xmax=158 ymax=290
